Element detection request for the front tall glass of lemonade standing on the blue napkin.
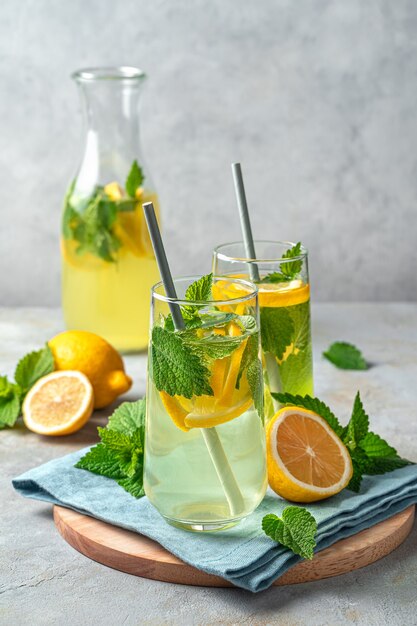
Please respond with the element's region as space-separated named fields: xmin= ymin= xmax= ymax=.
xmin=144 ymin=275 xmax=267 ymax=531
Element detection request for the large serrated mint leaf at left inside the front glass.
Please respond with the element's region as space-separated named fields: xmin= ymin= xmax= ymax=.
xmin=151 ymin=326 xmax=213 ymax=398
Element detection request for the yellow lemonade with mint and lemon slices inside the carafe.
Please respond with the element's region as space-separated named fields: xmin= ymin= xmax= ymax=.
xmin=61 ymin=171 xmax=159 ymax=352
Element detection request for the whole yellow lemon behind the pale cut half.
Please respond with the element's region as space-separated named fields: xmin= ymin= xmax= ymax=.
xmin=48 ymin=330 xmax=132 ymax=409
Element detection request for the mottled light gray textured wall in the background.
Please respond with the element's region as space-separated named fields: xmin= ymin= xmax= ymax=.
xmin=0 ymin=0 xmax=417 ymax=305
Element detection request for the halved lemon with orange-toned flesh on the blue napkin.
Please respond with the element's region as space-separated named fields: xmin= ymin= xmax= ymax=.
xmin=267 ymin=406 xmax=353 ymax=502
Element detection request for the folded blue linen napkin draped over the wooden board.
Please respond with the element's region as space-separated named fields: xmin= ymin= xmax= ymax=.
xmin=13 ymin=448 xmax=417 ymax=592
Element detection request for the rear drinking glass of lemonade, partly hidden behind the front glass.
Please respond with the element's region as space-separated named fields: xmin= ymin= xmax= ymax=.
xmin=213 ymin=241 xmax=313 ymax=417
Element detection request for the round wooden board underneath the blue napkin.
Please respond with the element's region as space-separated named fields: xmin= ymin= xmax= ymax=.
xmin=54 ymin=506 xmax=415 ymax=587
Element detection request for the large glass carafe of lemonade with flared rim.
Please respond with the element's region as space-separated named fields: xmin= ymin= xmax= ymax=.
xmin=61 ymin=67 xmax=159 ymax=351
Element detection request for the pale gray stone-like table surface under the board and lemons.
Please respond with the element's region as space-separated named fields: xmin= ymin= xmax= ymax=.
xmin=0 ymin=303 xmax=417 ymax=626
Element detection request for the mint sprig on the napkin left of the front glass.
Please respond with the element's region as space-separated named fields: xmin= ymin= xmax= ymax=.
xmin=75 ymin=399 xmax=145 ymax=498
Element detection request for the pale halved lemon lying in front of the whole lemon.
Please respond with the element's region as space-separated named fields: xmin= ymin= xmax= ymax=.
xmin=23 ymin=371 xmax=94 ymax=436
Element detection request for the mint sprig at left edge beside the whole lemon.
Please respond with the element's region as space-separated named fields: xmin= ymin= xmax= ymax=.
xmin=0 ymin=344 xmax=54 ymax=429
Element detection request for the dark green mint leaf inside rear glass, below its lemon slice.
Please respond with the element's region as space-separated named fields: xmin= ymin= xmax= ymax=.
xmin=260 ymin=307 xmax=294 ymax=360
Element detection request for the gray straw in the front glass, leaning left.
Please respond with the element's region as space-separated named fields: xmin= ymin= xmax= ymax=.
xmin=142 ymin=202 xmax=245 ymax=515
